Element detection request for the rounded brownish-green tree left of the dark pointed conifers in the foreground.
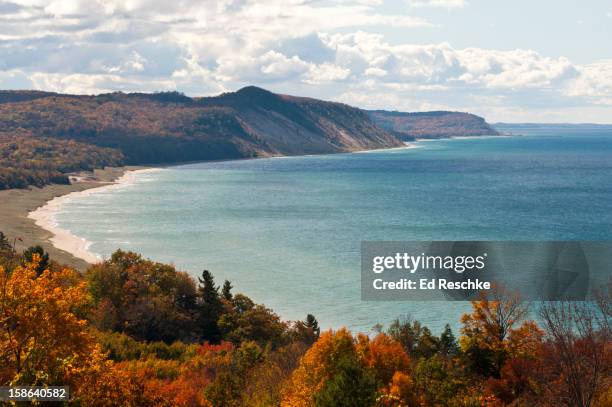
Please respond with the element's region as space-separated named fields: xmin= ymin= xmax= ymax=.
xmin=86 ymin=250 xmax=202 ymax=342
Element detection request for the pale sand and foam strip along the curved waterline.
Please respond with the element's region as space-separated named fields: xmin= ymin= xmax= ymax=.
xmin=28 ymin=168 xmax=161 ymax=263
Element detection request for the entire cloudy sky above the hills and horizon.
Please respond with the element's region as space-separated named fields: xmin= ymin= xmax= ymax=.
xmin=0 ymin=0 xmax=612 ymax=123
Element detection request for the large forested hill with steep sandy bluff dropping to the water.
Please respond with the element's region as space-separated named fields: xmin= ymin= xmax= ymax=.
xmin=0 ymin=87 xmax=402 ymax=189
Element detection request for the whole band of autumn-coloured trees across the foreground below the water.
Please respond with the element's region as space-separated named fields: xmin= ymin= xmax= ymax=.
xmin=0 ymin=235 xmax=612 ymax=407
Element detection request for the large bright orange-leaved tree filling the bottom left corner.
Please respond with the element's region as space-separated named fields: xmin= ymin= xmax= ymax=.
xmin=0 ymin=252 xmax=151 ymax=406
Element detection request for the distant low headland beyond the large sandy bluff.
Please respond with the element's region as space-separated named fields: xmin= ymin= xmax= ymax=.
xmin=368 ymin=110 xmax=499 ymax=140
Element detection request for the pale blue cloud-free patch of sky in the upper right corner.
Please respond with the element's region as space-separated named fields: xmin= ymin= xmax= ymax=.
xmin=385 ymin=0 xmax=612 ymax=64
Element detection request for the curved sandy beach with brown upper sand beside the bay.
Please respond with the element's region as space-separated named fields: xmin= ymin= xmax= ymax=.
xmin=0 ymin=167 xmax=143 ymax=270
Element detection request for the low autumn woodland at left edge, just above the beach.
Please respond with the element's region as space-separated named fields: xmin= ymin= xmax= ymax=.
xmin=0 ymin=133 xmax=123 ymax=190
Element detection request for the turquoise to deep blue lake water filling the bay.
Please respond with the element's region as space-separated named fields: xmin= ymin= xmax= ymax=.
xmin=57 ymin=131 xmax=612 ymax=332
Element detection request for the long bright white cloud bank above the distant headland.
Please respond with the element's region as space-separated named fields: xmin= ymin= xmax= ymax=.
xmin=326 ymin=32 xmax=578 ymax=89
